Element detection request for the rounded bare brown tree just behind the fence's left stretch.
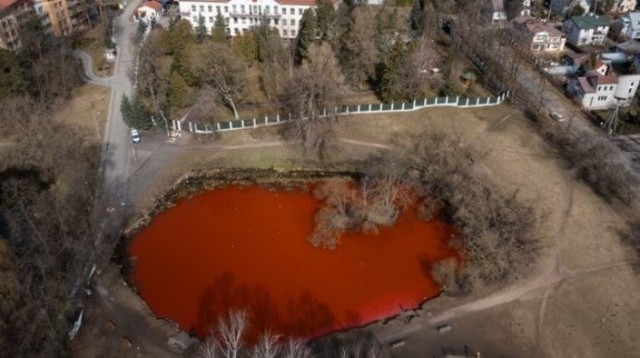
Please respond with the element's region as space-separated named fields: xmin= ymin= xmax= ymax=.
xmin=188 ymin=41 xmax=247 ymax=119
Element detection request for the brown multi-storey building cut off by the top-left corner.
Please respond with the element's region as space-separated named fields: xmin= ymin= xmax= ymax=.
xmin=0 ymin=0 xmax=31 ymax=51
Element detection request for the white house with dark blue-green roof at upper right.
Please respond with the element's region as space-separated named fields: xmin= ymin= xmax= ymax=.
xmin=562 ymin=15 xmax=611 ymax=46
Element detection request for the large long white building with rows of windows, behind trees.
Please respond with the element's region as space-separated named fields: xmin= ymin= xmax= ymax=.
xmin=180 ymin=0 xmax=315 ymax=39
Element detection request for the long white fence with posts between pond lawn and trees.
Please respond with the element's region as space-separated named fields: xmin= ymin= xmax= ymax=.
xmin=172 ymin=92 xmax=509 ymax=134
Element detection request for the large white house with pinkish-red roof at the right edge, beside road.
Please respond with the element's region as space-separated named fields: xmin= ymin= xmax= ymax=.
xmin=567 ymin=62 xmax=640 ymax=110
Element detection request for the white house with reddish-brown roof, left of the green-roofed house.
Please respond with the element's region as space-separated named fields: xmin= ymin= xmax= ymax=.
xmin=513 ymin=16 xmax=566 ymax=53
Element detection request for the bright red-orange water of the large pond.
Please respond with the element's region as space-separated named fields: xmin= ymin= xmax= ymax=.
xmin=129 ymin=186 xmax=455 ymax=339
